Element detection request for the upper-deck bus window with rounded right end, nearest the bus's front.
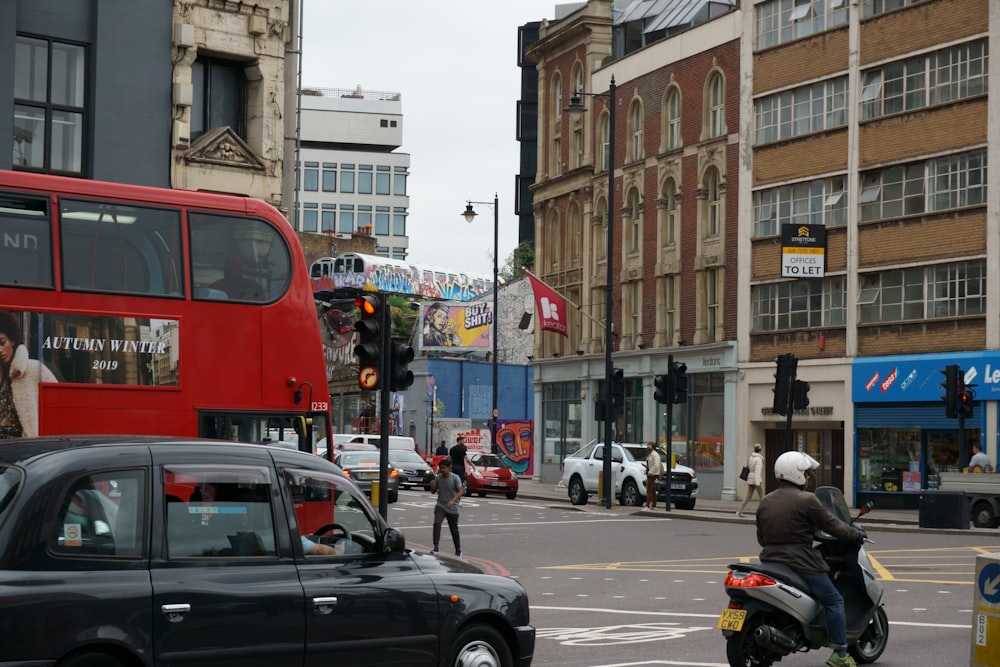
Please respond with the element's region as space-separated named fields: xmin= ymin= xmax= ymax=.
xmin=188 ymin=213 xmax=292 ymax=303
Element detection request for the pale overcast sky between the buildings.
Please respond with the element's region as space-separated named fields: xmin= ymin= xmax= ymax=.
xmin=302 ymin=0 xmax=558 ymax=275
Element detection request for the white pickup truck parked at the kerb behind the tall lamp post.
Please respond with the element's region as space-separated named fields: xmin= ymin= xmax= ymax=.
xmin=560 ymin=442 xmax=698 ymax=510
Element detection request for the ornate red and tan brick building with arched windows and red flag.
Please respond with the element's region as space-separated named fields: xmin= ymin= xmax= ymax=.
xmin=528 ymin=0 xmax=742 ymax=497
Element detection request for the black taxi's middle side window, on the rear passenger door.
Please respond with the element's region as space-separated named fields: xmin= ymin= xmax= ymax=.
xmin=163 ymin=466 xmax=277 ymax=559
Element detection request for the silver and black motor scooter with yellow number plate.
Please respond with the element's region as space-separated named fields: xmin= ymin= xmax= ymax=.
xmin=716 ymin=486 xmax=889 ymax=667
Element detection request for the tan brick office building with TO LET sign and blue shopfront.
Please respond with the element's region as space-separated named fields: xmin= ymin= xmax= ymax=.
xmin=730 ymin=0 xmax=1000 ymax=507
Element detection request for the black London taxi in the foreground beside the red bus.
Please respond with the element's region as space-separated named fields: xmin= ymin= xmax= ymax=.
xmin=0 ymin=436 xmax=535 ymax=667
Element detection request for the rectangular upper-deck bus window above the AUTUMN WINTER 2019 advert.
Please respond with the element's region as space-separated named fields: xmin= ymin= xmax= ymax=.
xmin=59 ymin=199 xmax=184 ymax=297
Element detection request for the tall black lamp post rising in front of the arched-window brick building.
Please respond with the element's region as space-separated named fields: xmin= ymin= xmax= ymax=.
xmin=565 ymin=76 xmax=616 ymax=509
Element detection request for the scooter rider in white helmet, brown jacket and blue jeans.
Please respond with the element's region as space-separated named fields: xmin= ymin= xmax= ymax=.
xmin=757 ymin=452 xmax=865 ymax=667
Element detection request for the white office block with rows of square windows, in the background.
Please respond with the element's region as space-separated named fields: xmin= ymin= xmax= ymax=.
xmin=294 ymin=86 xmax=410 ymax=259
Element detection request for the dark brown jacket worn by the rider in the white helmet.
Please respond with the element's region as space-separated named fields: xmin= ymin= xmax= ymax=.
xmin=757 ymin=482 xmax=861 ymax=574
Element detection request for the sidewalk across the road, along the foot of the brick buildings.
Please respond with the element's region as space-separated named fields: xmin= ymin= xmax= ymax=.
xmin=518 ymin=478 xmax=997 ymax=536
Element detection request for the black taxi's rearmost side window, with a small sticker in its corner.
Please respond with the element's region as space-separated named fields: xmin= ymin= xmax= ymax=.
xmin=49 ymin=470 xmax=147 ymax=558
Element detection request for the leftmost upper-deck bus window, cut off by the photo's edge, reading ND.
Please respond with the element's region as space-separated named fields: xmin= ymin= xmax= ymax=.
xmin=0 ymin=193 xmax=54 ymax=287
